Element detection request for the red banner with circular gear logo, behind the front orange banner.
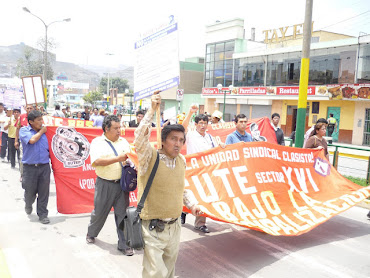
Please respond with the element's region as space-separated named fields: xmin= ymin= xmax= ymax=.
xmin=44 ymin=117 xmax=276 ymax=214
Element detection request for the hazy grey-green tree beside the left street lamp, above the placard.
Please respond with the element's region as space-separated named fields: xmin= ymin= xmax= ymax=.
xmin=17 ymin=46 xmax=54 ymax=80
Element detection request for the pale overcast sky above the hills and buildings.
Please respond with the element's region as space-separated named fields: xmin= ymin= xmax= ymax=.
xmin=0 ymin=0 xmax=370 ymax=66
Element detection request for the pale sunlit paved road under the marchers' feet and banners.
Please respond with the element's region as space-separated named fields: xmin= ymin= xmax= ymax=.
xmin=0 ymin=163 xmax=370 ymax=278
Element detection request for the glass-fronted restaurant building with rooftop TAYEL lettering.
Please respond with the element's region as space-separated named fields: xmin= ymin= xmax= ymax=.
xmin=202 ymin=19 xmax=370 ymax=145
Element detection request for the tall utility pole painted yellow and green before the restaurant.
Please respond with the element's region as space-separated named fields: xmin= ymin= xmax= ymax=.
xmin=295 ymin=0 xmax=313 ymax=148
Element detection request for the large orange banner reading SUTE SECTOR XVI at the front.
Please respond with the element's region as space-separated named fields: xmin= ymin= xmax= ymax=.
xmin=186 ymin=142 xmax=370 ymax=235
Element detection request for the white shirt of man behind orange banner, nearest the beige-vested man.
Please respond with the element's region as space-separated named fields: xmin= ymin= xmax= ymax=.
xmin=186 ymin=130 xmax=217 ymax=154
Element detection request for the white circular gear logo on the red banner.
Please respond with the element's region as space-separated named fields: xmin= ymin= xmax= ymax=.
xmin=51 ymin=127 xmax=90 ymax=168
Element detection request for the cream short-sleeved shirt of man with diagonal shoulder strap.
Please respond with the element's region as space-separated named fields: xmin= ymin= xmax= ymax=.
xmin=90 ymin=134 xmax=130 ymax=180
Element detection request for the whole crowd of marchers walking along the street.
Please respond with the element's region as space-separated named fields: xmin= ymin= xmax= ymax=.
xmin=0 ymin=99 xmax=346 ymax=277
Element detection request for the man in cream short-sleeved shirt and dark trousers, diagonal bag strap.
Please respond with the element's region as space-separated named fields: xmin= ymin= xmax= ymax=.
xmin=86 ymin=115 xmax=134 ymax=256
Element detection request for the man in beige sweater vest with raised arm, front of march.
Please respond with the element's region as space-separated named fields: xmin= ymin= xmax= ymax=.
xmin=134 ymin=91 xmax=201 ymax=278
